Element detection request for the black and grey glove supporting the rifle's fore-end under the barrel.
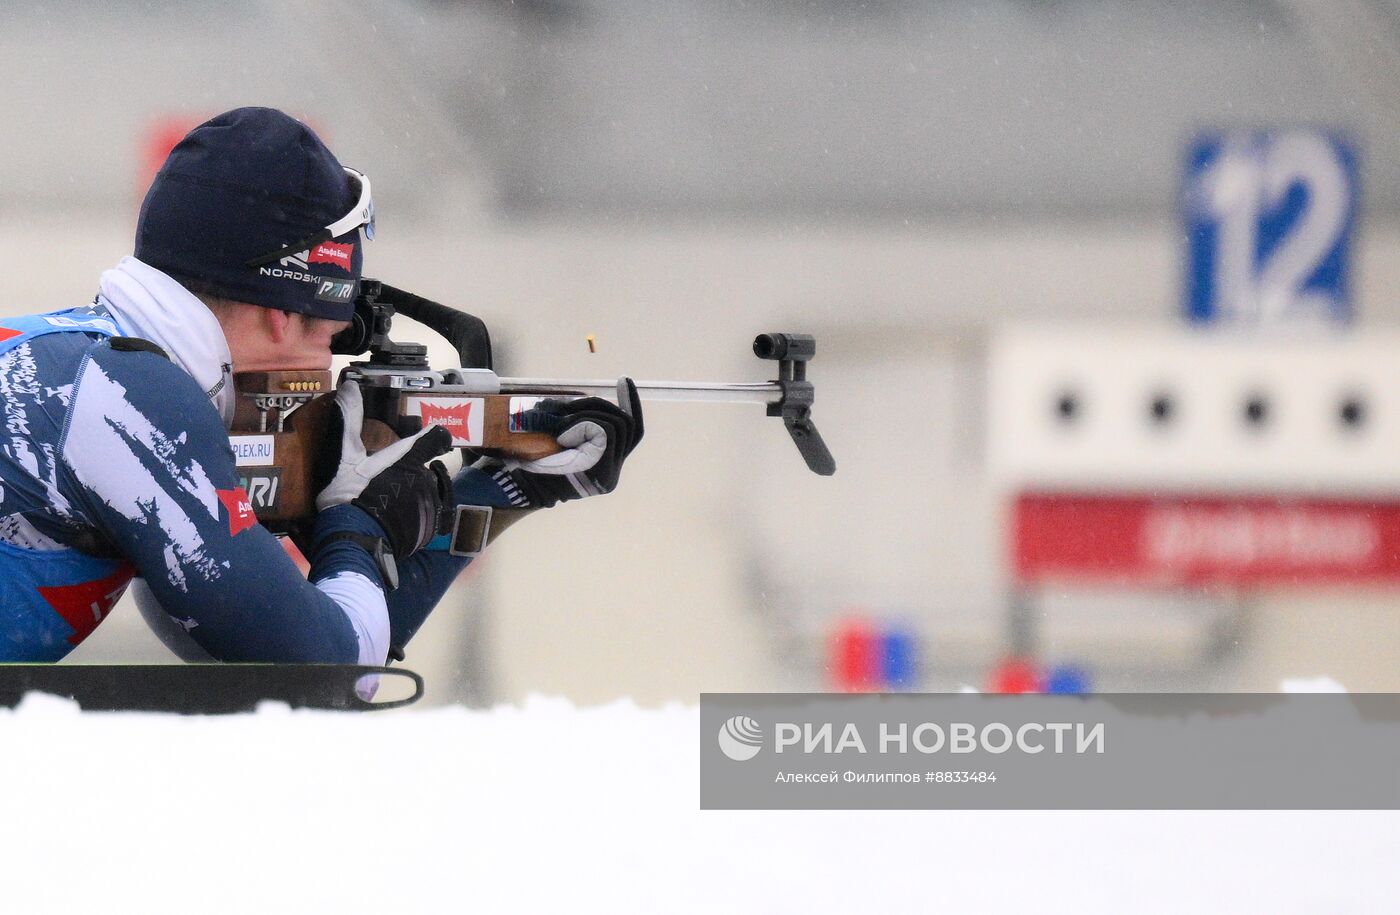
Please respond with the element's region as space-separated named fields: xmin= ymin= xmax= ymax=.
xmin=476 ymin=378 xmax=643 ymax=508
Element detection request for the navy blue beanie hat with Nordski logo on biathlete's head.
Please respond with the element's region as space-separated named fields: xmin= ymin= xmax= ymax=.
xmin=134 ymin=108 xmax=374 ymax=320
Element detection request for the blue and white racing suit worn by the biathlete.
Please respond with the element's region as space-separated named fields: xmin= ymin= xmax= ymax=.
xmin=0 ymin=257 xmax=510 ymax=665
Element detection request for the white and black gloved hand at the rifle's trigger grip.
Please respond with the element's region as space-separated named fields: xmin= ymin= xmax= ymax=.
xmin=316 ymin=381 xmax=452 ymax=560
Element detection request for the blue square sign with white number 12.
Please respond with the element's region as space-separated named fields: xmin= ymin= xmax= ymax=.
xmin=1182 ymin=129 xmax=1358 ymax=325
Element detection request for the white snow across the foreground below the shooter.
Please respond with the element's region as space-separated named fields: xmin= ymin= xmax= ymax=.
xmin=0 ymin=695 xmax=1400 ymax=914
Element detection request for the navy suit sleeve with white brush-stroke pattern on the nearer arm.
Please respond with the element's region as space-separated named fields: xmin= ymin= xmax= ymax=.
xmin=60 ymin=343 xmax=389 ymax=665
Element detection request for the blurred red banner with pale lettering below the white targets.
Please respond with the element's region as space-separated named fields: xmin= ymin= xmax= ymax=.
xmin=1012 ymin=492 xmax=1400 ymax=586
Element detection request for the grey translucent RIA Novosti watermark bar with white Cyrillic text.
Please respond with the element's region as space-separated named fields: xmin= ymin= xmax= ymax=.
xmin=700 ymin=694 xmax=1400 ymax=809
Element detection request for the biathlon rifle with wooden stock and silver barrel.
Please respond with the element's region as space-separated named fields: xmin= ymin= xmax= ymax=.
xmin=230 ymin=278 xmax=836 ymax=555
